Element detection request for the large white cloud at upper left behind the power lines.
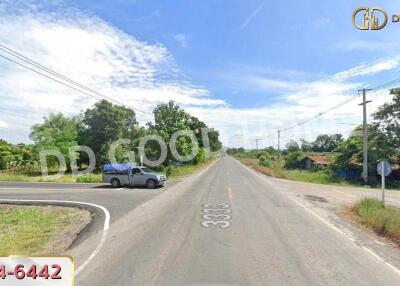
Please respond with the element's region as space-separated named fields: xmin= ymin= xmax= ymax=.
xmin=0 ymin=1 xmax=226 ymax=140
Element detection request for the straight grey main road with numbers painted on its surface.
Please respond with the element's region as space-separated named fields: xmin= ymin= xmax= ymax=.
xmin=61 ymin=157 xmax=400 ymax=286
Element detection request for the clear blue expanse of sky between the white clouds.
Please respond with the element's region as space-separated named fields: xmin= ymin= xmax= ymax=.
xmin=75 ymin=0 xmax=400 ymax=107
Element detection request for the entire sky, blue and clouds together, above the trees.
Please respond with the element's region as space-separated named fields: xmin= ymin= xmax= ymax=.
xmin=0 ymin=0 xmax=400 ymax=148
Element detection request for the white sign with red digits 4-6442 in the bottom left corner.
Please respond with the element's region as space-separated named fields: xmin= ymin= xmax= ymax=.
xmin=0 ymin=256 xmax=74 ymax=286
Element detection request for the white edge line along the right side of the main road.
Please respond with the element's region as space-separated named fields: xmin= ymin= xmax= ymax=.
xmin=239 ymin=159 xmax=400 ymax=275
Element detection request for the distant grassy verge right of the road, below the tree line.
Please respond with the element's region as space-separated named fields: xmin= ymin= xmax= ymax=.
xmin=239 ymin=159 xmax=352 ymax=186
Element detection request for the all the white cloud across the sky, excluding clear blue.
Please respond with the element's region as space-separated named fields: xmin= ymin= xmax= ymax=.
xmin=0 ymin=1 xmax=400 ymax=147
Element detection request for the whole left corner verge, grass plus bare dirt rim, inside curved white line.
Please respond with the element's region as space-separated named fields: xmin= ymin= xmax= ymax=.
xmin=0 ymin=205 xmax=90 ymax=256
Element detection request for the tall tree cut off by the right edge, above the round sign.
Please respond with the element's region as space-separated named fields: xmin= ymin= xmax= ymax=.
xmin=373 ymin=88 xmax=400 ymax=148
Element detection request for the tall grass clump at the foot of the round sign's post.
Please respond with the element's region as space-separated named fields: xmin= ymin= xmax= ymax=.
xmin=352 ymin=198 xmax=400 ymax=245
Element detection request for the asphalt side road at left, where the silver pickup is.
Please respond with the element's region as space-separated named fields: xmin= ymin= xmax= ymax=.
xmin=0 ymin=182 xmax=177 ymax=246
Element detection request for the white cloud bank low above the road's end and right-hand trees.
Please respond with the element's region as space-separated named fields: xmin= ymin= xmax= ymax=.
xmin=186 ymin=57 xmax=400 ymax=148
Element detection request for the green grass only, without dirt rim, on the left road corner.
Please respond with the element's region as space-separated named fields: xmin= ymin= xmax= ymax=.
xmin=0 ymin=205 xmax=90 ymax=256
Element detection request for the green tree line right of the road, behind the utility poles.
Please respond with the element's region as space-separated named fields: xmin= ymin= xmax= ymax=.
xmin=227 ymin=88 xmax=400 ymax=183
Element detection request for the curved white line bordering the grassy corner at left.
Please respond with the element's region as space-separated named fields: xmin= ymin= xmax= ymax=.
xmin=0 ymin=199 xmax=111 ymax=276
